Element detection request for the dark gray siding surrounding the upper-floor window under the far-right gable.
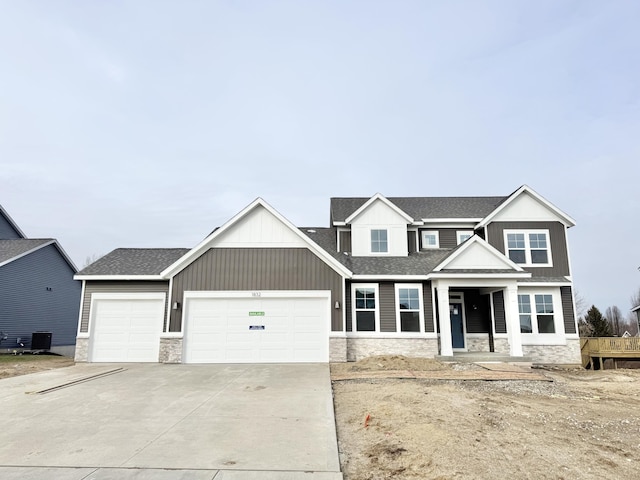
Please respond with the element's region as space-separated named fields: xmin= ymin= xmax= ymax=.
xmin=487 ymin=222 xmax=571 ymax=277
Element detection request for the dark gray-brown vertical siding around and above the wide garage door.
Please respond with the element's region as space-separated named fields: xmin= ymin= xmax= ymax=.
xmin=169 ymin=248 xmax=343 ymax=332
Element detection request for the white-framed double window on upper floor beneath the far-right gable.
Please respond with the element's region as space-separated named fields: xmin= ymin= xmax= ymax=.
xmin=504 ymin=230 xmax=552 ymax=267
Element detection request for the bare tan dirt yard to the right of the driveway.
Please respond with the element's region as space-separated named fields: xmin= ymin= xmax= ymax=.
xmin=331 ymin=357 xmax=640 ymax=480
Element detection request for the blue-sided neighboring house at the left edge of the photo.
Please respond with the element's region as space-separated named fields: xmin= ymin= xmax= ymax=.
xmin=0 ymin=206 xmax=81 ymax=356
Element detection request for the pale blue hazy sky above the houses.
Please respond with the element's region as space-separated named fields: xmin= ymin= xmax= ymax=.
xmin=0 ymin=0 xmax=640 ymax=312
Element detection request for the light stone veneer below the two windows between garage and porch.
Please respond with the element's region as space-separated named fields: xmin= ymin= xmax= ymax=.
xmin=346 ymin=338 xmax=438 ymax=362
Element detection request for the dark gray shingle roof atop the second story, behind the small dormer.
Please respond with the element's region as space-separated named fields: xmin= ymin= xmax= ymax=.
xmin=331 ymin=197 xmax=507 ymax=222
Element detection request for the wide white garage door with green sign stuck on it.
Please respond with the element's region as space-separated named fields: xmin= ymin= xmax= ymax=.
xmin=184 ymin=297 xmax=329 ymax=363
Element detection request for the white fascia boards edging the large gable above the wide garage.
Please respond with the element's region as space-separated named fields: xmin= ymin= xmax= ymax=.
xmin=160 ymin=197 xmax=351 ymax=279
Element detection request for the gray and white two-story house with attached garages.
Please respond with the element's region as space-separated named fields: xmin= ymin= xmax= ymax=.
xmin=76 ymin=186 xmax=580 ymax=364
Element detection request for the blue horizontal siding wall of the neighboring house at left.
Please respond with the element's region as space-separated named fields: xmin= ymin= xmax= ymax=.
xmin=0 ymin=245 xmax=82 ymax=349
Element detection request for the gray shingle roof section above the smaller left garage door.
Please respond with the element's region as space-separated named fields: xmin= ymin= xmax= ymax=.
xmin=78 ymin=248 xmax=189 ymax=275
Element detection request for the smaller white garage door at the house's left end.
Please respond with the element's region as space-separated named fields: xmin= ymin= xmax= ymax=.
xmin=90 ymin=298 xmax=164 ymax=362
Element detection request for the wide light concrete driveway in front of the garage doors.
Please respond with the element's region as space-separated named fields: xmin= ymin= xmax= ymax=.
xmin=0 ymin=364 xmax=342 ymax=480
